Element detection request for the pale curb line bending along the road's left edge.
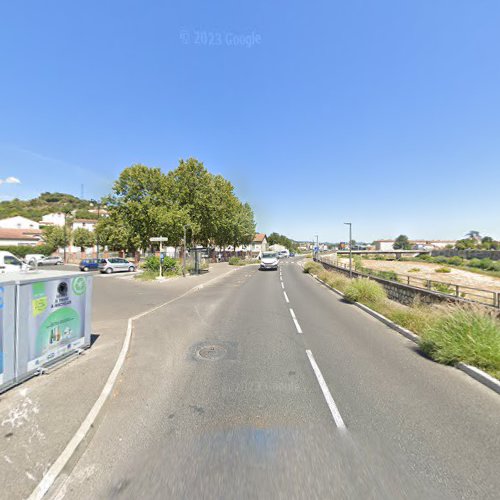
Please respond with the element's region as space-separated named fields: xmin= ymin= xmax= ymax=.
xmin=28 ymin=269 xmax=241 ymax=500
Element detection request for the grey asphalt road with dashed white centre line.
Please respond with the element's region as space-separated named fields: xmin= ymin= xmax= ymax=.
xmin=47 ymin=260 xmax=500 ymax=500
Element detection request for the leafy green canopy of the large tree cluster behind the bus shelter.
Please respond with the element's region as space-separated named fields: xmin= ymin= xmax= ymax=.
xmin=96 ymin=158 xmax=255 ymax=250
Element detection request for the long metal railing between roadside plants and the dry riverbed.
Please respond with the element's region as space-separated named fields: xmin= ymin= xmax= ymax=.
xmin=319 ymin=260 xmax=500 ymax=309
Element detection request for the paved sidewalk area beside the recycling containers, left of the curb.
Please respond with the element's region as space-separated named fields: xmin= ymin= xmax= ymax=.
xmin=0 ymin=263 xmax=238 ymax=499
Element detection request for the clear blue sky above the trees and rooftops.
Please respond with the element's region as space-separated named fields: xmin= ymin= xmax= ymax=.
xmin=0 ymin=0 xmax=500 ymax=241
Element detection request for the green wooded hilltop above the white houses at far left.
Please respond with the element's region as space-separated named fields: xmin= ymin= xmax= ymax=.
xmin=0 ymin=193 xmax=97 ymax=222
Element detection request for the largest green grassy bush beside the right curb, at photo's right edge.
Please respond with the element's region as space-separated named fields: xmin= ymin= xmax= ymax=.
xmin=420 ymin=309 xmax=500 ymax=378
